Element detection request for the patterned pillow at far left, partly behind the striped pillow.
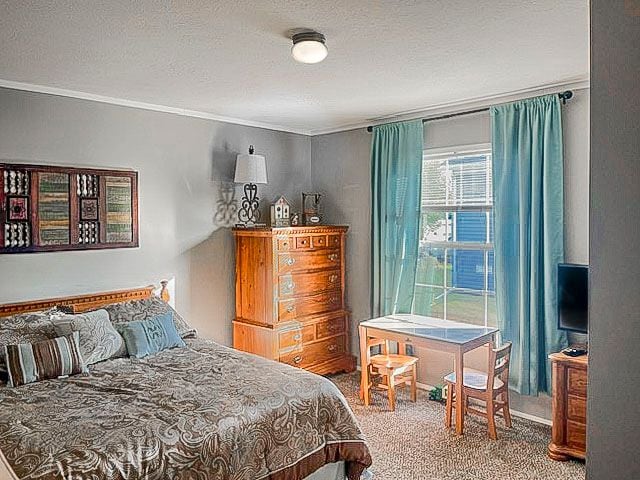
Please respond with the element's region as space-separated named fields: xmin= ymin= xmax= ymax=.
xmin=0 ymin=309 xmax=56 ymax=372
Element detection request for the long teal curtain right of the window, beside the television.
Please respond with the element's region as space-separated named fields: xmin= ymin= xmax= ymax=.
xmin=491 ymin=95 xmax=567 ymax=395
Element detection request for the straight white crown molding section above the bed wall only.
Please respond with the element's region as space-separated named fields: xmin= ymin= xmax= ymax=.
xmin=0 ymin=79 xmax=310 ymax=136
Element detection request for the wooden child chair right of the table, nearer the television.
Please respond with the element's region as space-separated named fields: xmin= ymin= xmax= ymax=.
xmin=444 ymin=342 xmax=511 ymax=440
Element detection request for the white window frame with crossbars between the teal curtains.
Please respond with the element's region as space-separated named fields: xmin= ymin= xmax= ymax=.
xmin=411 ymin=143 xmax=495 ymax=327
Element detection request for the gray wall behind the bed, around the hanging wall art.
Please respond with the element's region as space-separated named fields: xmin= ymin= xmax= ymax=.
xmin=0 ymin=89 xmax=311 ymax=345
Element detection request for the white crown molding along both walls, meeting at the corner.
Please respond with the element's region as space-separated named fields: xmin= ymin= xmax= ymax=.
xmin=0 ymin=78 xmax=590 ymax=137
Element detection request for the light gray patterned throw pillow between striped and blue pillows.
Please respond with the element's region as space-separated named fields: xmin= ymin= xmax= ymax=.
xmin=52 ymin=310 xmax=126 ymax=365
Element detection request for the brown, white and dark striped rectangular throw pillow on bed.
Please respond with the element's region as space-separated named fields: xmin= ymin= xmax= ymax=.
xmin=4 ymin=332 xmax=87 ymax=387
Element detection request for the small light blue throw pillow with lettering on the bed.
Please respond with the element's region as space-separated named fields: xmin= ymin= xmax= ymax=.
xmin=117 ymin=312 xmax=186 ymax=358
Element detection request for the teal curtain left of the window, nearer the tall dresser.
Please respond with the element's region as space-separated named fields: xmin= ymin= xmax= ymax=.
xmin=371 ymin=120 xmax=424 ymax=317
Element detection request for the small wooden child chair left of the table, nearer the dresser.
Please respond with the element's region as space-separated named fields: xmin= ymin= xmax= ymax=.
xmin=360 ymin=338 xmax=418 ymax=411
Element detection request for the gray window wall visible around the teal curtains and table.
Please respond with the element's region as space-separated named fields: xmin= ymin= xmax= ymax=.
xmin=311 ymin=90 xmax=589 ymax=419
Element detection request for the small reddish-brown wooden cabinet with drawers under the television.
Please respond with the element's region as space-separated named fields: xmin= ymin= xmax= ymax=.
xmin=548 ymin=353 xmax=588 ymax=460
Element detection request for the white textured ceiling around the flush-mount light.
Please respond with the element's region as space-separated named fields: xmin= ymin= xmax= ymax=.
xmin=0 ymin=0 xmax=589 ymax=133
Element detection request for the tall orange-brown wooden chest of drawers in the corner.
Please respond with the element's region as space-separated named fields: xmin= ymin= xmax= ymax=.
xmin=233 ymin=225 xmax=355 ymax=375
